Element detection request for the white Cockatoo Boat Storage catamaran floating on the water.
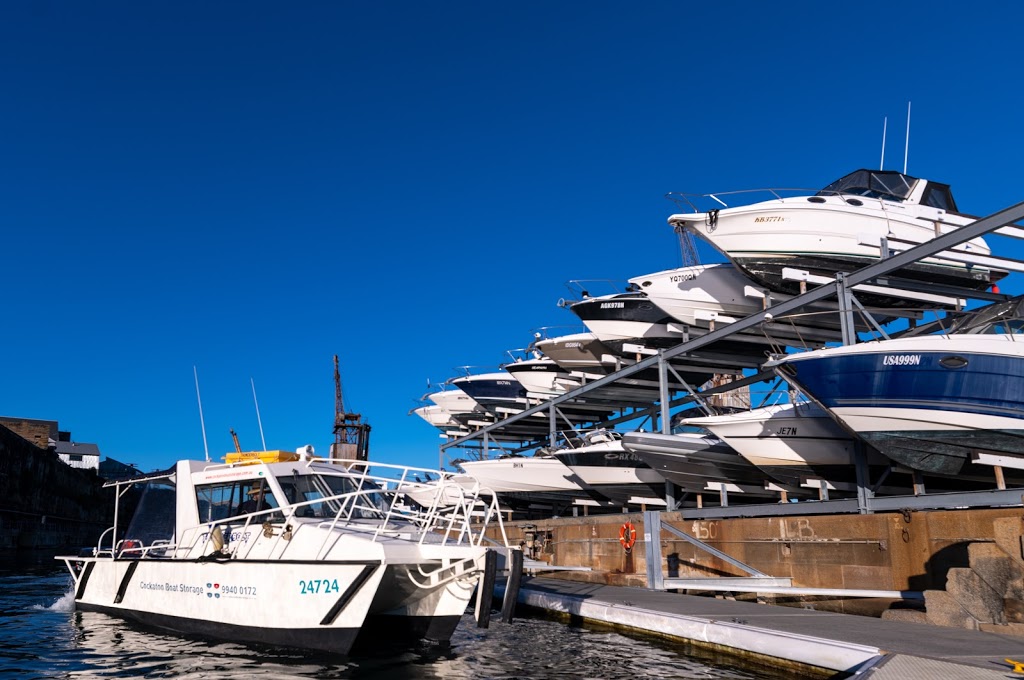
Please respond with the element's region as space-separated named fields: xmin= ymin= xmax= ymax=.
xmin=57 ymin=447 xmax=507 ymax=654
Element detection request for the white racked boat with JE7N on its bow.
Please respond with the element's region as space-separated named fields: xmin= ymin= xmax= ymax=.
xmin=682 ymin=401 xmax=892 ymax=487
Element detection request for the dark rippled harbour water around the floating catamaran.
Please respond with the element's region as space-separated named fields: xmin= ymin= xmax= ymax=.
xmin=0 ymin=556 xmax=793 ymax=680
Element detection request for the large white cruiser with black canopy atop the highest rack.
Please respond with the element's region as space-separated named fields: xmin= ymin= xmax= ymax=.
xmin=669 ymin=170 xmax=1007 ymax=294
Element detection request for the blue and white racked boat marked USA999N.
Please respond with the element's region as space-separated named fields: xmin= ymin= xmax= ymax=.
xmin=771 ymin=334 xmax=1024 ymax=475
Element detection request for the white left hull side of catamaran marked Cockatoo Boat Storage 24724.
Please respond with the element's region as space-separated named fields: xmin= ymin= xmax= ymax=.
xmin=75 ymin=558 xmax=384 ymax=654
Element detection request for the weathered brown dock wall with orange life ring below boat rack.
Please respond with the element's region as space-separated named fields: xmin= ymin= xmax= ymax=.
xmin=487 ymin=508 xmax=1024 ymax=615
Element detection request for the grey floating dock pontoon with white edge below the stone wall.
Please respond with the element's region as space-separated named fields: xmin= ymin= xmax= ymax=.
xmin=496 ymin=576 xmax=1024 ymax=680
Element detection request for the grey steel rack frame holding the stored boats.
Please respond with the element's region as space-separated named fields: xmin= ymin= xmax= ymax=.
xmin=440 ymin=203 xmax=1024 ymax=519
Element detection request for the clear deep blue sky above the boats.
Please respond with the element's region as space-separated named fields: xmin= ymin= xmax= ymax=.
xmin=0 ymin=0 xmax=1024 ymax=469
